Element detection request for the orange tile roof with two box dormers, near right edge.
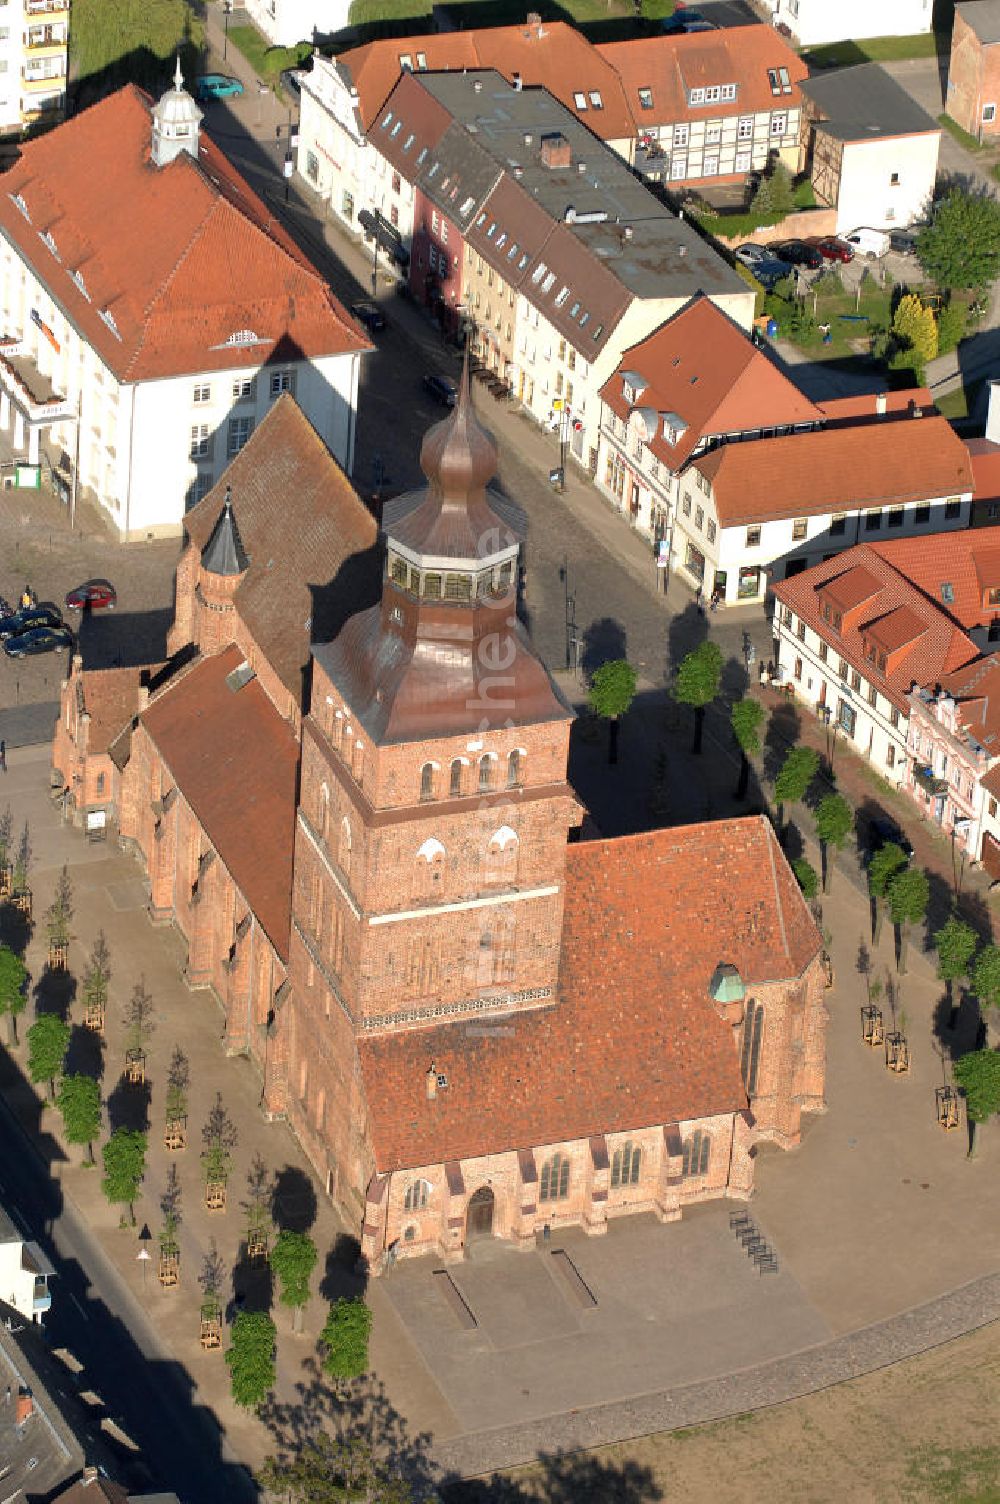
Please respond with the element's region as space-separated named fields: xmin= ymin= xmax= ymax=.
xmin=773 ymin=544 xmax=979 ymax=711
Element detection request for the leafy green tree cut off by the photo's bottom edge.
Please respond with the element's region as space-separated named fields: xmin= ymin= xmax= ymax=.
xmin=257 ymin=1430 xmax=415 ymax=1504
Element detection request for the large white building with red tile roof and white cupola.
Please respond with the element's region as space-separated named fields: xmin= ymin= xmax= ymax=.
xmin=0 ymin=71 xmax=370 ymax=538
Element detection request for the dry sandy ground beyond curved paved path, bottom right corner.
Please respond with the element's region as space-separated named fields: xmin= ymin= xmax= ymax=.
xmin=490 ymin=1325 xmax=1000 ymax=1504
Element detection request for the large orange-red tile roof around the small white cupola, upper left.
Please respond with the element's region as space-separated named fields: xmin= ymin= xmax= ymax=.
xmin=0 ymin=86 xmax=370 ymax=382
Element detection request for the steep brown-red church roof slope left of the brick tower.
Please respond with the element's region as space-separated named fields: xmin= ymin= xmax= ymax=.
xmin=140 ymin=647 xmax=299 ymax=961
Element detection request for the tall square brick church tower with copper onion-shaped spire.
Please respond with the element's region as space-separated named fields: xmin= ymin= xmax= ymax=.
xmin=290 ymin=363 xmax=580 ymax=1209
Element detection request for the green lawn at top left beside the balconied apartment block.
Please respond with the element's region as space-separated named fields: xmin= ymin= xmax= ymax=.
xmin=69 ymin=0 xmax=205 ymax=104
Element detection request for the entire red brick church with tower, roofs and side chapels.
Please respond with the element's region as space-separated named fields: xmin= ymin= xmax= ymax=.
xmin=54 ymin=381 xmax=826 ymax=1272
